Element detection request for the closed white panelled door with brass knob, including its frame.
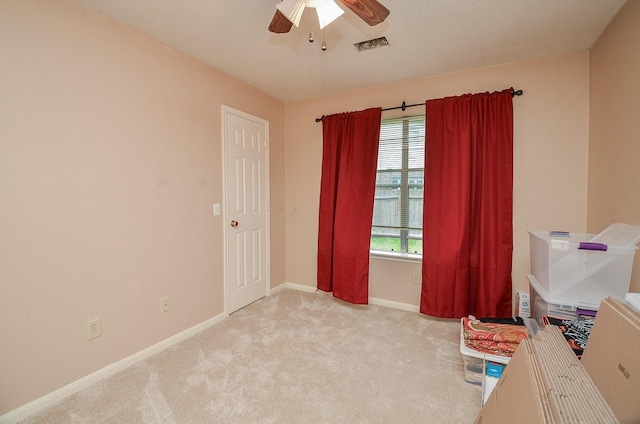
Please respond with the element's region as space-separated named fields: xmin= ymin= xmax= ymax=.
xmin=223 ymin=106 xmax=269 ymax=313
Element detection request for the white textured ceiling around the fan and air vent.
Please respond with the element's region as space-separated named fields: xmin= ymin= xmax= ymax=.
xmin=76 ymin=0 xmax=625 ymax=101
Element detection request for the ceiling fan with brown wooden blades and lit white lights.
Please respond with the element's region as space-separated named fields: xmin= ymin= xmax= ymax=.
xmin=269 ymin=0 xmax=389 ymax=34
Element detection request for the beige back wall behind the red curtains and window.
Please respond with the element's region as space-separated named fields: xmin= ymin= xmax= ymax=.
xmin=285 ymin=52 xmax=589 ymax=305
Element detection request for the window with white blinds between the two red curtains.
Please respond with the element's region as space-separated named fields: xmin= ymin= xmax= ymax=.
xmin=371 ymin=115 xmax=425 ymax=255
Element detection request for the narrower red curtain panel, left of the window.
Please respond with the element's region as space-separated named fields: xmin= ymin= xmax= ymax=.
xmin=318 ymin=108 xmax=382 ymax=304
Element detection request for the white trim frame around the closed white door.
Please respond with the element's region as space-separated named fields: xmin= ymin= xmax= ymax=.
xmin=221 ymin=104 xmax=271 ymax=316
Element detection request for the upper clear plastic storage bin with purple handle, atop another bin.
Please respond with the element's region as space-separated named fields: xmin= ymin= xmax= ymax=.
xmin=529 ymin=224 xmax=640 ymax=306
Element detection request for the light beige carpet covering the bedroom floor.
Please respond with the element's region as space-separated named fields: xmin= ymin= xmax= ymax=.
xmin=22 ymin=289 xmax=481 ymax=424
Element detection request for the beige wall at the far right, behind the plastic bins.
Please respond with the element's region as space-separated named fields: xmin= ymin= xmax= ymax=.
xmin=587 ymin=0 xmax=640 ymax=292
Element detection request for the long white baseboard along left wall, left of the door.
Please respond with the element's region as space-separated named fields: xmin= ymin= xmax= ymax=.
xmin=0 ymin=313 xmax=229 ymax=424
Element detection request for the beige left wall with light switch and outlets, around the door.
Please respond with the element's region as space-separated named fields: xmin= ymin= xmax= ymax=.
xmin=0 ymin=0 xmax=285 ymax=415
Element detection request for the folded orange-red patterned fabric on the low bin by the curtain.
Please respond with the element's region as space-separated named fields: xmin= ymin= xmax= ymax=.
xmin=462 ymin=317 xmax=529 ymax=356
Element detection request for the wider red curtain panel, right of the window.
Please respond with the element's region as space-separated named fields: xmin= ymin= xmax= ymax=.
xmin=420 ymin=89 xmax=513 ymax=318
